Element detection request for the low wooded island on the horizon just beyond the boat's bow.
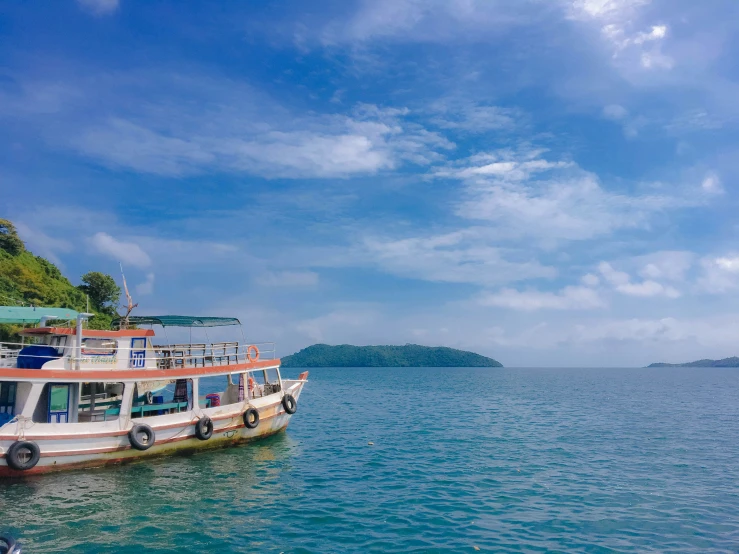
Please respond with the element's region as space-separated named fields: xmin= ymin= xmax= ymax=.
xmin=282 ymin=344 xmax=503 ymax=368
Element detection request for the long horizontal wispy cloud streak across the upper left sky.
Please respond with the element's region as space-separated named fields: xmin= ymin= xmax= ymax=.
xmin=71 ymin=105 xmax=454 ymax=178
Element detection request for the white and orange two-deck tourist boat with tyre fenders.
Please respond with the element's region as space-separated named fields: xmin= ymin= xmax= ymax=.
xmin=0 ymin=310 xmax=308 ymax=477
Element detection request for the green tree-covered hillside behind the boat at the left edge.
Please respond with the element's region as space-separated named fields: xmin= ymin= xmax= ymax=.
xmin=0 ymin=219 xmax=121 ymax=341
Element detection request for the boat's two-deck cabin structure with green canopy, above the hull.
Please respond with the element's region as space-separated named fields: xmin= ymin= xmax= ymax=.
xmin=0 ymin=310 xmax=282 ymax=428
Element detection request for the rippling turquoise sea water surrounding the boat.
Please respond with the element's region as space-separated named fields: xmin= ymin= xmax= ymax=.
xmin=0 ymin=368 xmax=739 ymax=554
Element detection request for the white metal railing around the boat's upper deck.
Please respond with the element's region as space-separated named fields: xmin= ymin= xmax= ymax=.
xmin=0 ymin=340 xmax=276 ymax=369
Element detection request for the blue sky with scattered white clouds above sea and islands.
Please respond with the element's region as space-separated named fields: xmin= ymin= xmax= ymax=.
xmin=0 ymin=0 xmax=739 ymax=366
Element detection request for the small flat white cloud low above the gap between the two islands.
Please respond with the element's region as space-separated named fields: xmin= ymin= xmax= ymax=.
xmin=478 ymin=287 xmax=605 ymax=311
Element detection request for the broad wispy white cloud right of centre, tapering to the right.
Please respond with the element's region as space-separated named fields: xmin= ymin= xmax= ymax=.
xmin=440 ymin=150 xmax=697 ymax=244
